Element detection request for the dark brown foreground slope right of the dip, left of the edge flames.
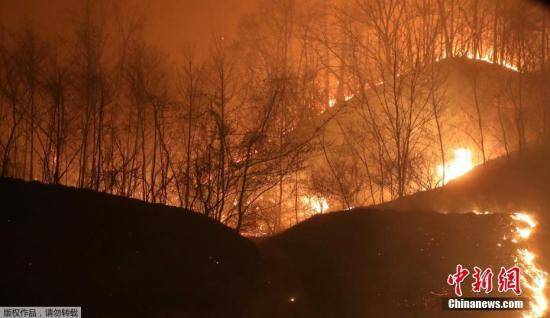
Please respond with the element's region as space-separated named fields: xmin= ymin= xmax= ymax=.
xmin=262 ymin=209 xmax=520 ymax=318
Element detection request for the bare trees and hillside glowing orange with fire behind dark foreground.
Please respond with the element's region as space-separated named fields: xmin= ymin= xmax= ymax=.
xmin=0 ymin=0 xmax=550 ymax=235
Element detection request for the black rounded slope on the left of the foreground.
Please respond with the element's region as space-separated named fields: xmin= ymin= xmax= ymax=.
xmin=0 ymin=179 xmax=259 ymax=317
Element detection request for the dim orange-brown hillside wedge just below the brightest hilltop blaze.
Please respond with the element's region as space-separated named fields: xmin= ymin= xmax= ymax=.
xmin=380 ymin=146 xmax=550 ymax=214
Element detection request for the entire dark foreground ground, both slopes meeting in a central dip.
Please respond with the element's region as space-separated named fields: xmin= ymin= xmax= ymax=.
xmin=0 ymin=174 xmax=540 ymax=317
